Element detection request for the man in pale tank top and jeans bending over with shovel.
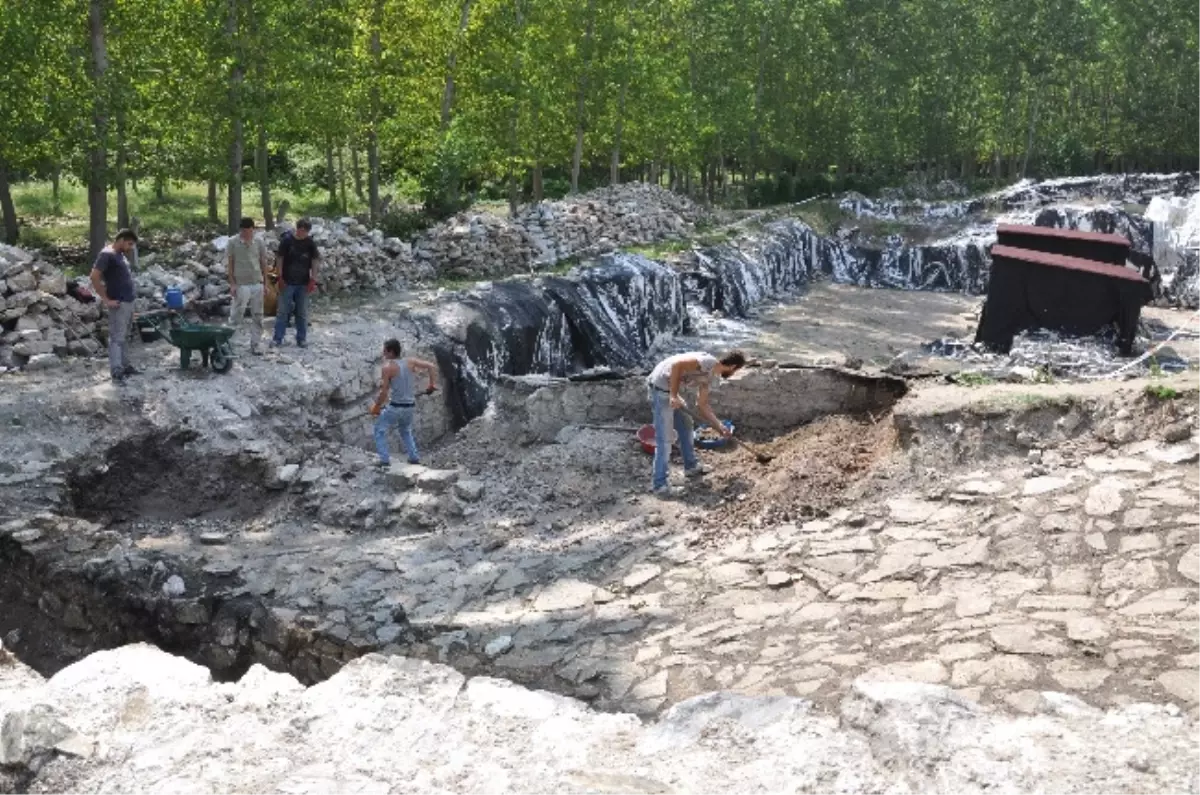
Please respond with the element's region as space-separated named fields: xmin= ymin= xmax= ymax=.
xmin=647 ymin=351 xmax=746 ymax=495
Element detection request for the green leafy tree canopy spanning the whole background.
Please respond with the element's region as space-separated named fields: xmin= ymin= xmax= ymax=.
xmin=0 ymin=0 xmax=1200 ymax=249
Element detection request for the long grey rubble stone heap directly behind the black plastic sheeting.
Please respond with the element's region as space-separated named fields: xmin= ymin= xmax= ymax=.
xmin=415 ymin=183 xmax=703 ymax=279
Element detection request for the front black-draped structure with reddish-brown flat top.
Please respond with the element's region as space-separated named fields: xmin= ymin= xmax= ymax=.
xmin=976 ymin=244 xmax=1152 ymax=355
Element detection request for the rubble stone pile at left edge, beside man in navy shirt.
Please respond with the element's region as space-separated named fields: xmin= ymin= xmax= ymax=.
xmin=0 ymin=245 xmax=101 ymax=373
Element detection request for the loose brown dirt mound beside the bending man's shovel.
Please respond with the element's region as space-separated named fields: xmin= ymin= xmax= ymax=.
xmin=710 ymin=416 xmax=896 ymax=537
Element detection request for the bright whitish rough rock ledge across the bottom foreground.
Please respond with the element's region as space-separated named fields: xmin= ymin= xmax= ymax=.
xmin=0 ymin=645 xmax=1200 ymax=795
